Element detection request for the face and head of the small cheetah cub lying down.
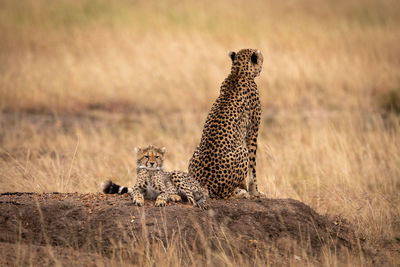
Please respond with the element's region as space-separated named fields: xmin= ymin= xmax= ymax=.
xmin=135 ymin=146 xmax=167 ymax=170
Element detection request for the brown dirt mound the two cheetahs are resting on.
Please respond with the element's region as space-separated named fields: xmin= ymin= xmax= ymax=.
xmin=0 ymin=193 xmax=358 ymax=266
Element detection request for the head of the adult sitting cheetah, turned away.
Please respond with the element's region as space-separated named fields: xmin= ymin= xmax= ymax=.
xmin=229 ymin=49 xmax=264 ymax=78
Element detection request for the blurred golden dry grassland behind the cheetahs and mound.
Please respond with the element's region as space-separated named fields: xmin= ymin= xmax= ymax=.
xmin=0 ymin=0 xmax=400 ymax=265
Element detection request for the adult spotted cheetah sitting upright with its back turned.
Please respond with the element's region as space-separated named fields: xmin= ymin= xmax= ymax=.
xmin=189 ymin=49 xmax=263 ymax=198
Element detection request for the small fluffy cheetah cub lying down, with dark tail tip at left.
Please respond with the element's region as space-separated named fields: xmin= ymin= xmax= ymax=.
xmin=102 ymin=146 xmax=208 ymax=209
